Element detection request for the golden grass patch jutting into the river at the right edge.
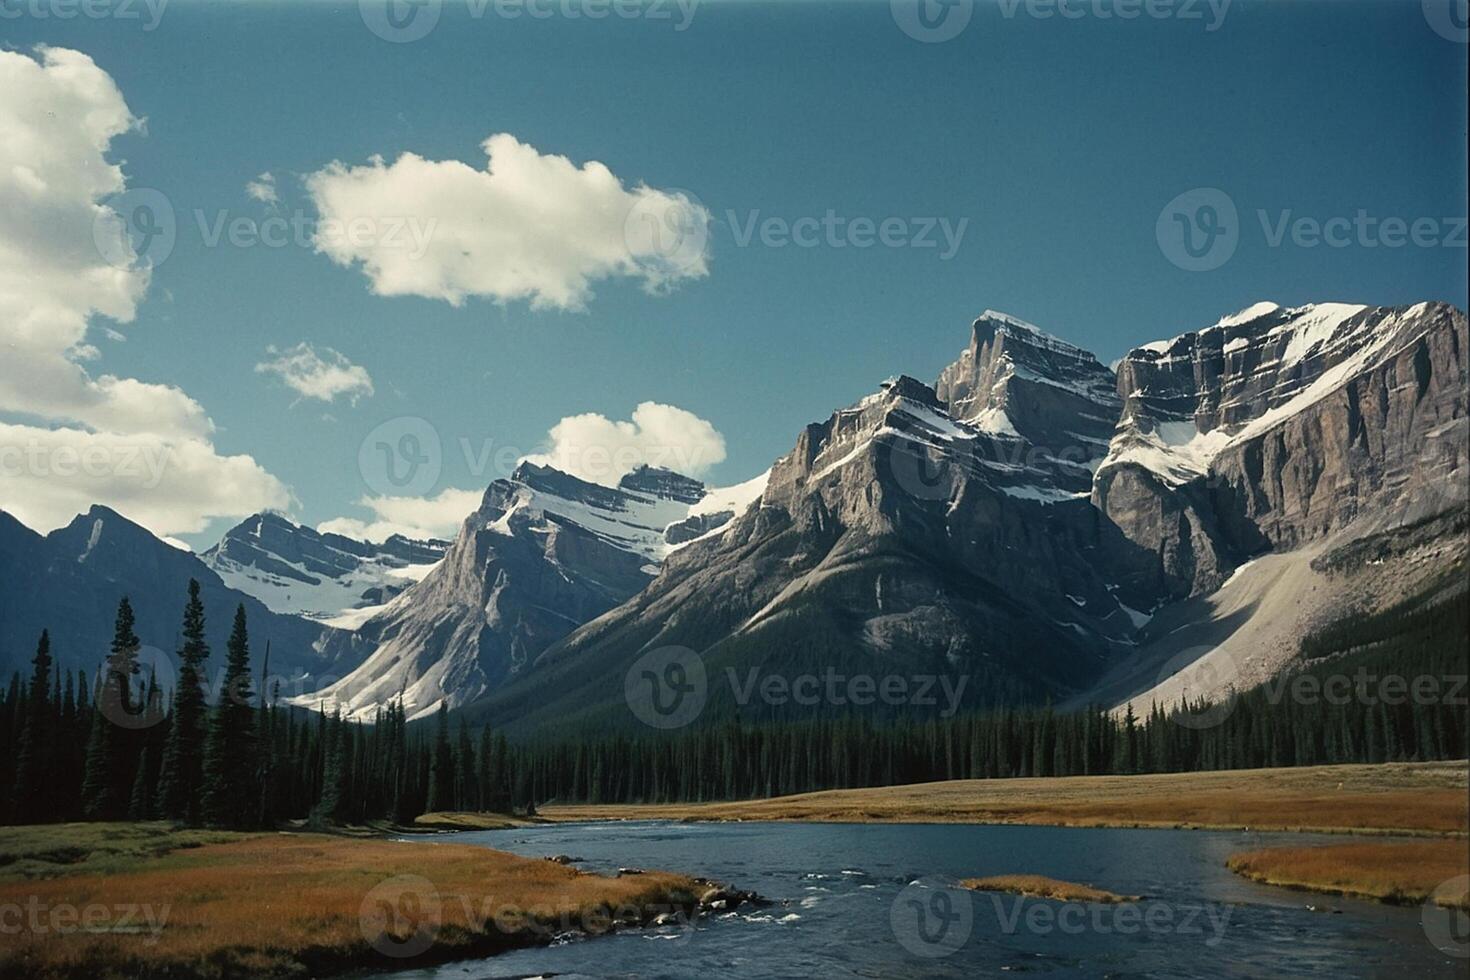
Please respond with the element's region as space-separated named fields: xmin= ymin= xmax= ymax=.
xmin=1226 ymin=840 xmax=1470 ymax=911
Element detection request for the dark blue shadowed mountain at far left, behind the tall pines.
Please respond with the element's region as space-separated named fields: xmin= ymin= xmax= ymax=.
xmin=0 ymin=507 xmax=356 ymax=693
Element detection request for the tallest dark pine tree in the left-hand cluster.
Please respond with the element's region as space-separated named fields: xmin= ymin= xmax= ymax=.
xmin=159 ymin=579 xmax=209 ymax=824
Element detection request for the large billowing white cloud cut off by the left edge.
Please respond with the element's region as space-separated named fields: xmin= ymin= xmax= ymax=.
xmin=0 ymin=47 xmax=290 ymax=533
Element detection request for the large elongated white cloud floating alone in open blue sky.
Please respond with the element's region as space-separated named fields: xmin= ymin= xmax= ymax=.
xmin=306 ymin=134 xmax=710 ymax=310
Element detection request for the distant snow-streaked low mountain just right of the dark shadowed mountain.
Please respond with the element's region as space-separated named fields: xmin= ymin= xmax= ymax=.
xmin=200 ymin=514 xmax=448 ymax=627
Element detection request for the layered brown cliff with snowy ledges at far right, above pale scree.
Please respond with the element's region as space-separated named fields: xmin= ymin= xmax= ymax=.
xmin=1092 ymin=303 xmax=1467 ymax=597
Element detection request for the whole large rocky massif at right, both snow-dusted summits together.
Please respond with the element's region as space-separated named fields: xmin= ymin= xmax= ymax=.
xmin=464 ymin=304 xmax=1470 ymax=729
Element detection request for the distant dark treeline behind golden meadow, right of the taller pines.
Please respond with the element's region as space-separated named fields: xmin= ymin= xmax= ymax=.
xmin=473 ymin=592 xmax=1470 ymax=802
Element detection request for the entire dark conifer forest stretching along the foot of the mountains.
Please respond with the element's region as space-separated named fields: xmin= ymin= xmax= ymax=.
xmin=0 ymin=583 xmax=1470 ymax=829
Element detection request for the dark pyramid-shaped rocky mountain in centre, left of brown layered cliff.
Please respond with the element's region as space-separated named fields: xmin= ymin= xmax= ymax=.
xmin=470 ymin=313 xmax=1142 ymax=724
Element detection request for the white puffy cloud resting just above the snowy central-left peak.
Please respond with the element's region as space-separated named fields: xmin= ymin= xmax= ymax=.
xmin=526 ymin=401 xmax=725 ymax=486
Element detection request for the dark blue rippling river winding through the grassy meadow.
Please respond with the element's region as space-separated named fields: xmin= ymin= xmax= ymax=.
xmin=364 ymin=821 xmax=1466 ymax=980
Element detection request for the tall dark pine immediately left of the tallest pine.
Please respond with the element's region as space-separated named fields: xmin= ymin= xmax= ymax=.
xmin=82 ymin=595 xmax=141 ymax=820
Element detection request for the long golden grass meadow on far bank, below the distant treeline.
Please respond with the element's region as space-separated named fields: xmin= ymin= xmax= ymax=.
xmin=539 ymin=763 xmax=1470 ymax=835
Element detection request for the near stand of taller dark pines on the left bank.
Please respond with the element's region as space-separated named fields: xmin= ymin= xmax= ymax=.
xmin=0 ymin=582 xmax=516 ymax=829
